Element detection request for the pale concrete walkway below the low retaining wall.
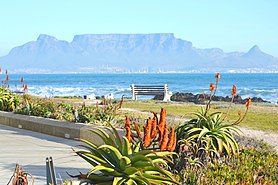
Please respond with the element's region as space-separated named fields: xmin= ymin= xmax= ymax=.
xmin=0 ymin=125 xmax=91 ymax=185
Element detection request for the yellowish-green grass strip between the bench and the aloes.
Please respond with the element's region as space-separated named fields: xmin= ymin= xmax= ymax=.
xmin=124 ymin=100 xmax=278 ymax=133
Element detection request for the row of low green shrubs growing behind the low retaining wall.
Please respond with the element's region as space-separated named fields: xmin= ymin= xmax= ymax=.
xmin=15 ymin=94 xmax=123 ymax=123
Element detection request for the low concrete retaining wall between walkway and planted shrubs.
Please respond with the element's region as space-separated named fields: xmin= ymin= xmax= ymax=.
xmin=0 ymin=111 xmax=122 ymax=144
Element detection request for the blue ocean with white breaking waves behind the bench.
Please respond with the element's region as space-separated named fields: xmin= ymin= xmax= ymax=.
xmin=0 ymin=73 xmax=278 ymax=103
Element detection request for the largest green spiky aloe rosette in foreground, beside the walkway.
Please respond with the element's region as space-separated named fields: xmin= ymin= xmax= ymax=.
xmin=74 ymin=123 xmax=178 ymax=185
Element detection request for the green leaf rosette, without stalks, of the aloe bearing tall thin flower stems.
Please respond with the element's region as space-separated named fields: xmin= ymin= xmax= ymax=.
xmin=176 ymin=109 xmax=239 ymax=157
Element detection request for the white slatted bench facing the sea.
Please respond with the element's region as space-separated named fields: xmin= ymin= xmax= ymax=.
xmin=131 ymin=84 xmax=172 ymax=101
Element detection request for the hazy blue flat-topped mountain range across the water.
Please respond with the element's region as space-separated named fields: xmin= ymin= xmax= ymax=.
xmin=0 ymin=33 xmax=278 ymax=73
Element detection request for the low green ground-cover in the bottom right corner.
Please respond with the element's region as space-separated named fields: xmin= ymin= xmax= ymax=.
xmin=180 ymin=140 xmax=278 ymax=185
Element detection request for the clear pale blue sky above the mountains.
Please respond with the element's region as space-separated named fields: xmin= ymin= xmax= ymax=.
xmin=0 ymin=0 xmax=278 ymax=57
